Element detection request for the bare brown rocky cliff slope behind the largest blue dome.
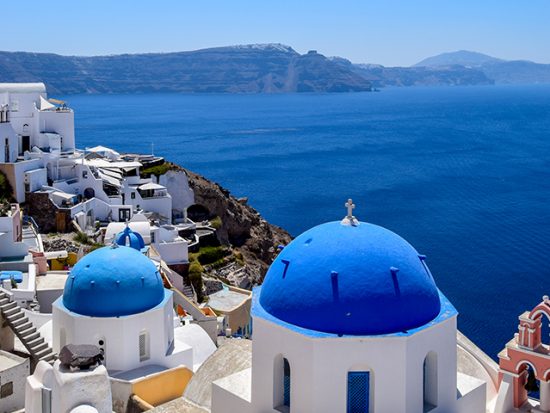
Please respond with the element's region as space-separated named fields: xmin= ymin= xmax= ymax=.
xmin=186 ymin=166 xmax=291 ymax=287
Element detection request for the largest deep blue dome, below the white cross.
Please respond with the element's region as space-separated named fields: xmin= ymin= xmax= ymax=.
xmin=259 ymin=222 xmax=441 ymax=335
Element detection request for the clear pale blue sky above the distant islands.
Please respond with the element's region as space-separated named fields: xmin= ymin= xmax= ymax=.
xmin=4 ymin=0 xmax=550 ymax=65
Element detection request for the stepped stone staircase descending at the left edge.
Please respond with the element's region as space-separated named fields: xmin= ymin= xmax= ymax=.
xmin=0 ymin=290 xmax=56 ymax=365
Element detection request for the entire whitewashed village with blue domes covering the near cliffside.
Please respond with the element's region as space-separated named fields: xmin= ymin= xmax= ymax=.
xmin=0 ymin=83 xmax=550 ymax=413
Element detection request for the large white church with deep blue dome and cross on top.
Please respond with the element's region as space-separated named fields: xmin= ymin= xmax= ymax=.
xmin=208 ymin=200 xmax=486 ymax=413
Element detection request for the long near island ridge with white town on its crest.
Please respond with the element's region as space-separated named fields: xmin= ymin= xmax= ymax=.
xmin=0 ymin=44 xmax=371 ymax=94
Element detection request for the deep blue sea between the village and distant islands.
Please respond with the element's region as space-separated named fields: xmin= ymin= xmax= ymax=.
xmin=62 ymin=85 xmax=550 ymax=358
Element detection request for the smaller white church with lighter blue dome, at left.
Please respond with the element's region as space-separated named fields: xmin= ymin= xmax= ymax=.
xmin=52 ymin=243 xmax=193 ymax=374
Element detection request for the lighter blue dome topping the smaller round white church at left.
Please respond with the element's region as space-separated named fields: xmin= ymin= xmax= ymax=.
xmin=63 ymin=246 xmax=165 ymax=317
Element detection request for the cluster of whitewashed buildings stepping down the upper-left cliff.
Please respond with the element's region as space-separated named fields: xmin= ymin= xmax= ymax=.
xmin=0 ymin=83 xmax=194 ymax=264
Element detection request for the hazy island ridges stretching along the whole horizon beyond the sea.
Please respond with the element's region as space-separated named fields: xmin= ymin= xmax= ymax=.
xmin=0 ymin=44 xmax=550 ymax=94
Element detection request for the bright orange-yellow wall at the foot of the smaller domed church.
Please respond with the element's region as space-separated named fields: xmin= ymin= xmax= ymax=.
xmin=132 ymin=367 xmax=193 ymax=406
